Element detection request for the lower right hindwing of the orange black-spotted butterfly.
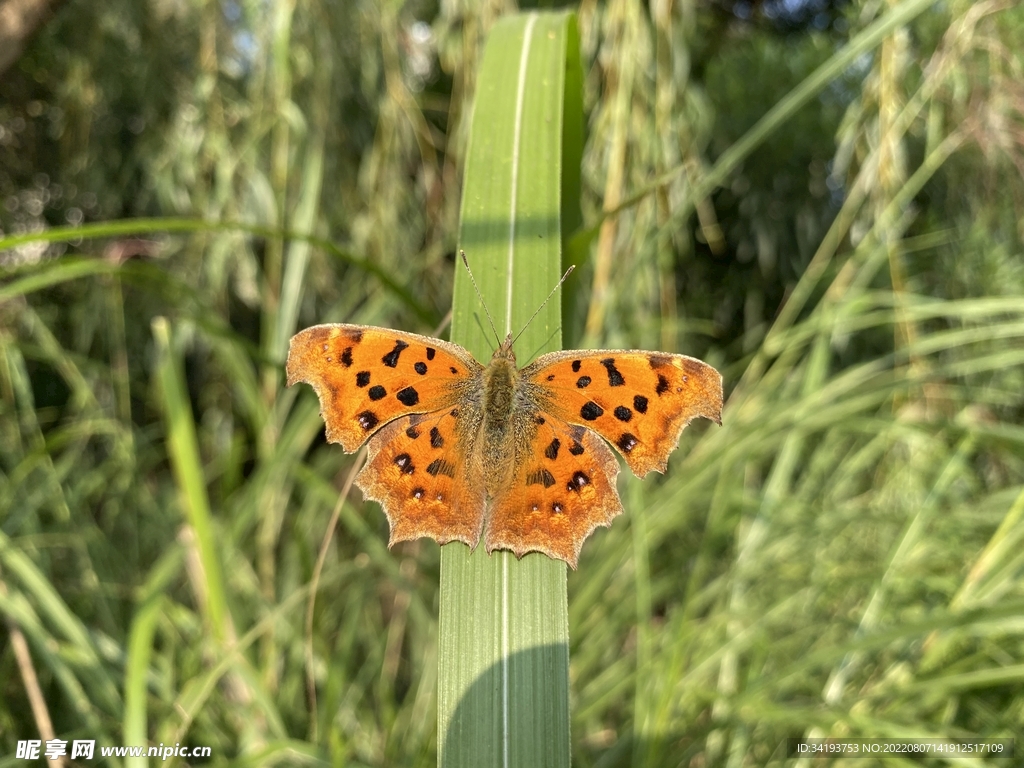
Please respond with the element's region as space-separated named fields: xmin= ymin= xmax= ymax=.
xmin=485 ymin=413 xmax=623 ymax=568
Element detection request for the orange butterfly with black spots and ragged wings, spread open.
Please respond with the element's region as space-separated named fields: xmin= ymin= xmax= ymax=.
xmin=287 ymin=309 xmax=722 ymax=568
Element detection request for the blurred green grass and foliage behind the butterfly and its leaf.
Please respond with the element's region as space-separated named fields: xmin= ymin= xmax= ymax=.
xmin=0 ymin=0 xmax=1024 ymax=766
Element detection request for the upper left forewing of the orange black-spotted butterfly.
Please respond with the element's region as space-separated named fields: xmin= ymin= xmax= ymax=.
xmin=286 ymin=324 xmax=483 ymax=453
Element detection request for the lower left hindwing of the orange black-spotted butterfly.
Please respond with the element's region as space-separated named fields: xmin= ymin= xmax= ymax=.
xmin=355 ymin=403 xmax=486 ymax=547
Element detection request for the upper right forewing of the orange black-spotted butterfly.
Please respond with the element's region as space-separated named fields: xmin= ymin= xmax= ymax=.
xmin=522 ymin=350 xmax=722 ymax=477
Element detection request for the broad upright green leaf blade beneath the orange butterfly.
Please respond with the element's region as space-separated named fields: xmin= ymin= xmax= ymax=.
xmin=438 ymin=13 xmax=582 ymax=767
